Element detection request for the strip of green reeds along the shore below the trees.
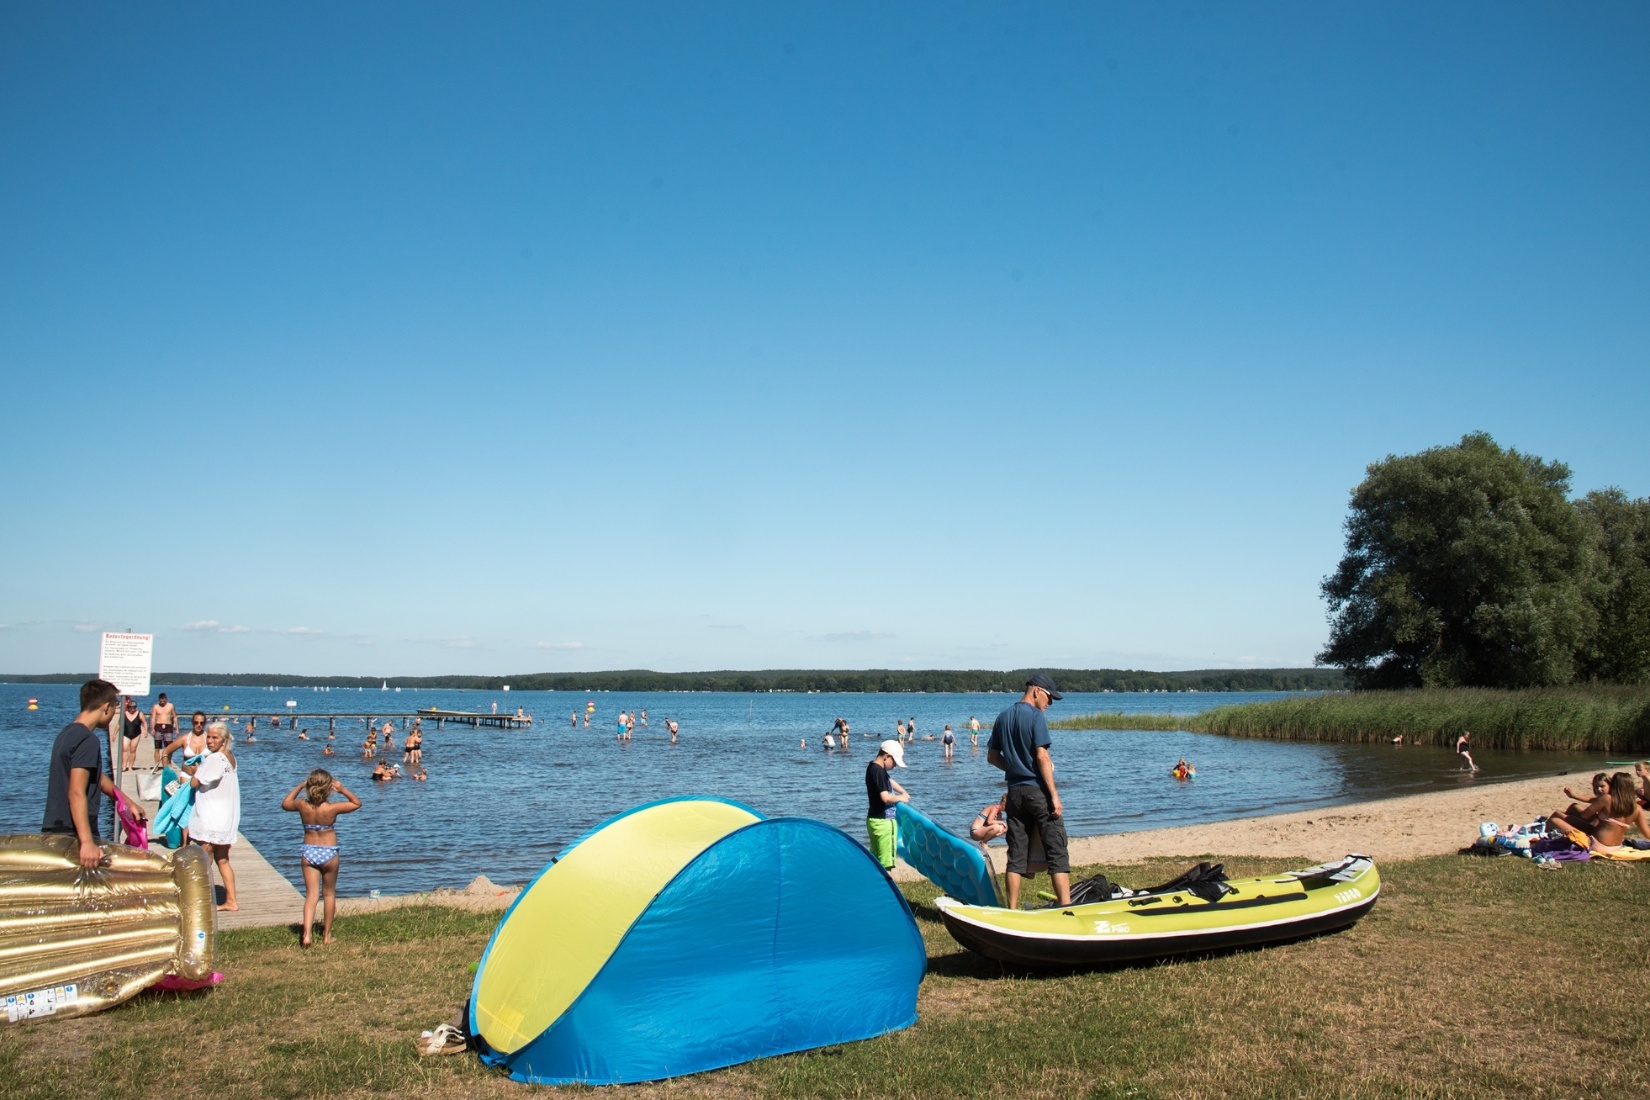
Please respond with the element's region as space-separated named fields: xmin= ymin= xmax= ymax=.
xmin=1051 ymin=686 xmax=1650 ymax=755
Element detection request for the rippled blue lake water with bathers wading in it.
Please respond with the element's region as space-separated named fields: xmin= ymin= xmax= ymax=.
xmin=0 ymin=684 xmax=1602 ymax=896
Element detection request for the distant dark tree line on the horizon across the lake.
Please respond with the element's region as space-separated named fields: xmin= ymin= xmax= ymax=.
xmin=0 ymin=668 xmax=1346 ymax=693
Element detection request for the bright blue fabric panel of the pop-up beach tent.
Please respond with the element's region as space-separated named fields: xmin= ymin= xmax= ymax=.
xmin=500 ymin=818 xmax=927 ymax=1085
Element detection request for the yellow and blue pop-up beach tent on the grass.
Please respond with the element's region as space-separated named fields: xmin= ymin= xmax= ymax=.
xmin=470 ymin=798 xmax=927 ymax=1085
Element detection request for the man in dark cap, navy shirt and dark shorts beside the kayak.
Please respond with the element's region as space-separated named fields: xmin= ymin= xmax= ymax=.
xmin=985 ymin=673 xmax=1071 ymax=909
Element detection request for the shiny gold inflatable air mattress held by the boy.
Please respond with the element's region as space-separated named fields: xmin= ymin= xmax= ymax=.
xmin=0 ymin=834 xmax=218 ymax=1022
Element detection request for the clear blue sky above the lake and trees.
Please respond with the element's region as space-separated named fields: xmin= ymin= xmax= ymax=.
xmin=0 ymin=3 xmax=1650 ymax=675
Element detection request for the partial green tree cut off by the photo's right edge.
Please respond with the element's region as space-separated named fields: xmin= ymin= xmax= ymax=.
xmin=1576 ymin=488 xmax=1650 ymax=684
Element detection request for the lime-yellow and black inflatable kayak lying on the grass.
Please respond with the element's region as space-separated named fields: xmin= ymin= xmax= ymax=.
xmin=936 ymin=856 xmax=1381 ymax=966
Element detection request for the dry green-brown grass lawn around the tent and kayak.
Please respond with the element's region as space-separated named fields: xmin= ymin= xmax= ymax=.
xmin=0 ymin=856 xmax=1650 ymax=1100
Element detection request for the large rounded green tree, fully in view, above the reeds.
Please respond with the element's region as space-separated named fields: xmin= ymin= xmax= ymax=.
xmin=1318 ymin=432 xmax=1597 ymax=688
